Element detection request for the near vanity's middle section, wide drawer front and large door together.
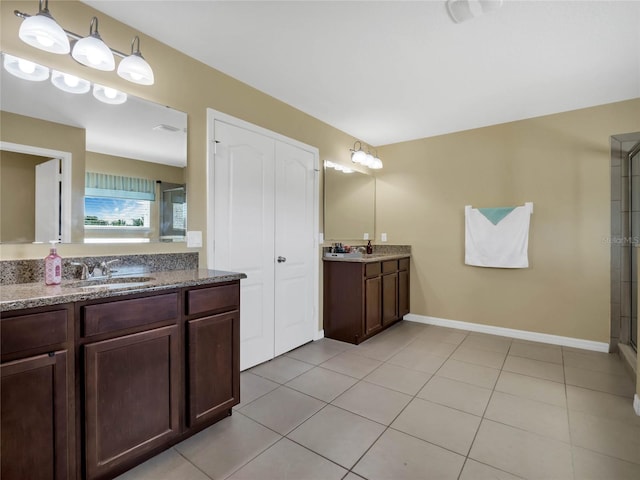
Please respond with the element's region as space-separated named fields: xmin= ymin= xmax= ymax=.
xmin=80 ymin=292 xmax=182 ymax=479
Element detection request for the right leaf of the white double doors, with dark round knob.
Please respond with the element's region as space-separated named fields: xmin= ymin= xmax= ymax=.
xmin=275 ymin=142 xmax=315 ymax=356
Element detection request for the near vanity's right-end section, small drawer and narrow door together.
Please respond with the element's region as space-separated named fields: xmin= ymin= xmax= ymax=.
xmin=185 ymin=284 xmax=240 ymax=428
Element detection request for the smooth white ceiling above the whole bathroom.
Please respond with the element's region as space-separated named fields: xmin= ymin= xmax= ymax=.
xmin=82 ymin=0 xmax=640 ymax=146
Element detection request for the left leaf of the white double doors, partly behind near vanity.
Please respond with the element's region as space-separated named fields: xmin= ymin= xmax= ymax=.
xmin=213 ymin=122 xmax=275 ymax=370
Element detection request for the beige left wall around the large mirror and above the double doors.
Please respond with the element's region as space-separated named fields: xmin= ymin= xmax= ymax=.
xmin=0 ymin=0 xmax=354 ymax=266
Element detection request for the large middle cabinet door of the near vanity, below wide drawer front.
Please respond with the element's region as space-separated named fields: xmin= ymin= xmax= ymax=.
xmin=84 ymin=325 xmax=181 ymax=479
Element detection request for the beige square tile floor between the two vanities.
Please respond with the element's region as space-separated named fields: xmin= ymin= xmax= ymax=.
xmin=119 ymin=321 xmax=640 ymax=480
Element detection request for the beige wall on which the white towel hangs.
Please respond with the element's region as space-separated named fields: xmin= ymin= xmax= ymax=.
xmin=376 ymin=99 xmax=640 ymax=342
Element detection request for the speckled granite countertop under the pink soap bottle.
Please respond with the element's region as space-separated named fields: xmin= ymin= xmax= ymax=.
xmin=0 ymin=269 xmax=247 ymax=312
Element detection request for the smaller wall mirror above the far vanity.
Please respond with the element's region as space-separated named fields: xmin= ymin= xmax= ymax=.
xmin=324 ymin=162 xmax=376 ymax=241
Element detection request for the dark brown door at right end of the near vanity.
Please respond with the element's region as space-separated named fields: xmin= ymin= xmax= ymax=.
xmin=187 ymin=310 xmax=240 ymax=427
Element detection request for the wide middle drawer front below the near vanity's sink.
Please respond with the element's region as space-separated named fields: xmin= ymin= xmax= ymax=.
xmin=82 ymin=293 xmax=178 ymax=337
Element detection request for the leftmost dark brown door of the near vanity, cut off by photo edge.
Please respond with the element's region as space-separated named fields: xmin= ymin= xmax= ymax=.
xmin=0 ymin=351 xmax=69 ymax=480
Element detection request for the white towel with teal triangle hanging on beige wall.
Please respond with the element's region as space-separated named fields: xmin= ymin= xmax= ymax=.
xmin=464 ymin=202 xmax=533 ymax=268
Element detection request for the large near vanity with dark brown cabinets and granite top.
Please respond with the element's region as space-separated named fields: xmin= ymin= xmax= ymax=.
xmin=0 ymin=264 xmax=245 ymax=479
